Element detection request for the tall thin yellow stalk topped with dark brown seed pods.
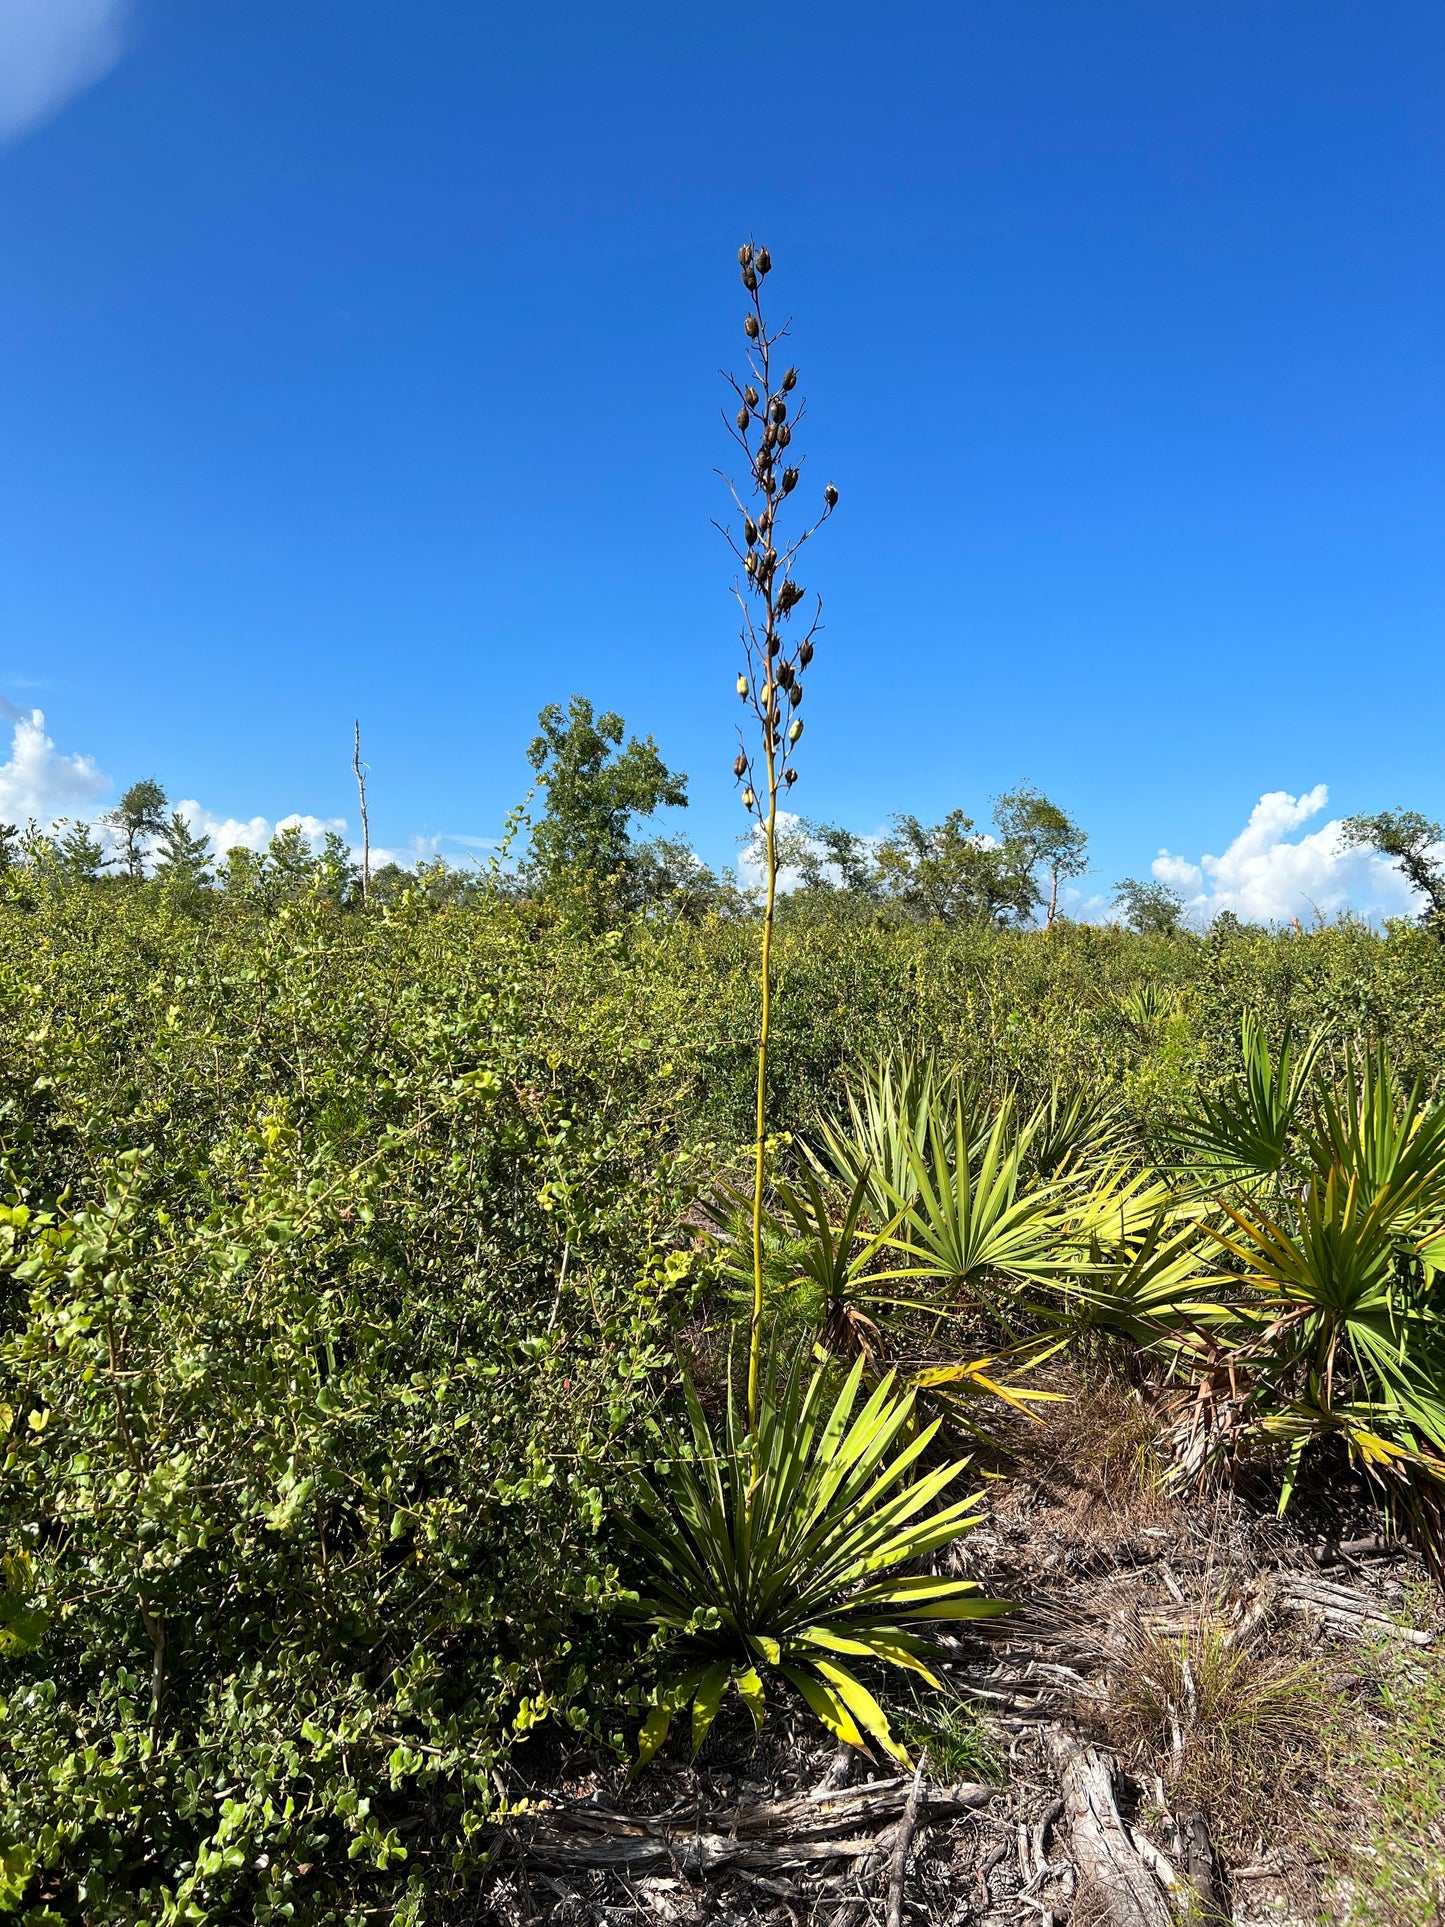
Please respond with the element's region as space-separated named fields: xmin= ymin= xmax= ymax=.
xmin=717 ymin=241 xmax=838 ymax=1434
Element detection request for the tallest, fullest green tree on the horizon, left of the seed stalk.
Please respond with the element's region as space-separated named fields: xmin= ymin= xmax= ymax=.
xmin=526 ymin=696 xmax=688 ymax=923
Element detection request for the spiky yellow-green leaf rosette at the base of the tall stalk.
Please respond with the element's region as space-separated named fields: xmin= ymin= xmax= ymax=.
xmin=634 ymin=1357 xmax=1008 ymax=1763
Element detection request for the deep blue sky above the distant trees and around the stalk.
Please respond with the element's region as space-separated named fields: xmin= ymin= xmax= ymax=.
xmin=0 ymin=0 xmax=1445 ymax=913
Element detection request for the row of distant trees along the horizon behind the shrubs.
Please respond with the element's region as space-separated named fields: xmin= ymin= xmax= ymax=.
xmin=0 ymin=696 xmax=1445 ymax=935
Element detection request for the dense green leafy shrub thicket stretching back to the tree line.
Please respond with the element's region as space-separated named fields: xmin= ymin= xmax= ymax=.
xmin=0 ymin=881 xmax=1445 ymax=1923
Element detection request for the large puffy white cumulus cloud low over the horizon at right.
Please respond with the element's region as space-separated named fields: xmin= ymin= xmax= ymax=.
xmin=1152 ymin=782 xmax=1420 ymax=923
